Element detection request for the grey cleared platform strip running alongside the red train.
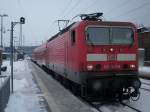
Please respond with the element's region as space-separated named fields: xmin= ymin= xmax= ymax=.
xmin=28 ymin=62 xmax=95 ymax=112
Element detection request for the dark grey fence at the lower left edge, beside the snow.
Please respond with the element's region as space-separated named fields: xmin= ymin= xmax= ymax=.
xmin=0 ymin=76 xmax=10 ymax=112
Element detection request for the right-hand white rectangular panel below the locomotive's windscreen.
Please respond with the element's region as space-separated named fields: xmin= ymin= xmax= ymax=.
xmin=117 ymin=54 xmax=136 ymax=61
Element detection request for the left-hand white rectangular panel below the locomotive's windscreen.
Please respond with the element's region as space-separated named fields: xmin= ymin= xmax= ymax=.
xmin=86 ymin=54 xmax=107 ymax=61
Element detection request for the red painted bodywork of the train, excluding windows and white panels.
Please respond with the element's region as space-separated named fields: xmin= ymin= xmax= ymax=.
xmin=33 ymin=21 xmax=138 ymax=74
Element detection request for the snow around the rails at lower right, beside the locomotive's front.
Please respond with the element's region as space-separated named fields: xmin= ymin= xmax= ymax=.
xmin=100 ymin=79 xmax=150 ymax=112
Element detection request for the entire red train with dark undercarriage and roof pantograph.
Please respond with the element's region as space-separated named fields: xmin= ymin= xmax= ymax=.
xmin=32 ymin=13 xmax=141 ymax=100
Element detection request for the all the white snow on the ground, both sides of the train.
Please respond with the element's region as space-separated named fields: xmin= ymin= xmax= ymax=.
xmin=3 ymin=61 xmax=150 ymax=112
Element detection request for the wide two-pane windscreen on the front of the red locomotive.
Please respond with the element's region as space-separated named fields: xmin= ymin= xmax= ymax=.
xmin=86 ymin=27 xmax=134 ymax=45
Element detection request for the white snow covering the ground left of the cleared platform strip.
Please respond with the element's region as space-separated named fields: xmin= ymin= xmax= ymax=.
xmin=3 ymin=61 xmax=46 ymax=112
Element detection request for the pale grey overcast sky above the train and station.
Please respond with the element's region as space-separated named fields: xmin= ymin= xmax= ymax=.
xmin=0 ymin=0 xmax=150 ymax=45
